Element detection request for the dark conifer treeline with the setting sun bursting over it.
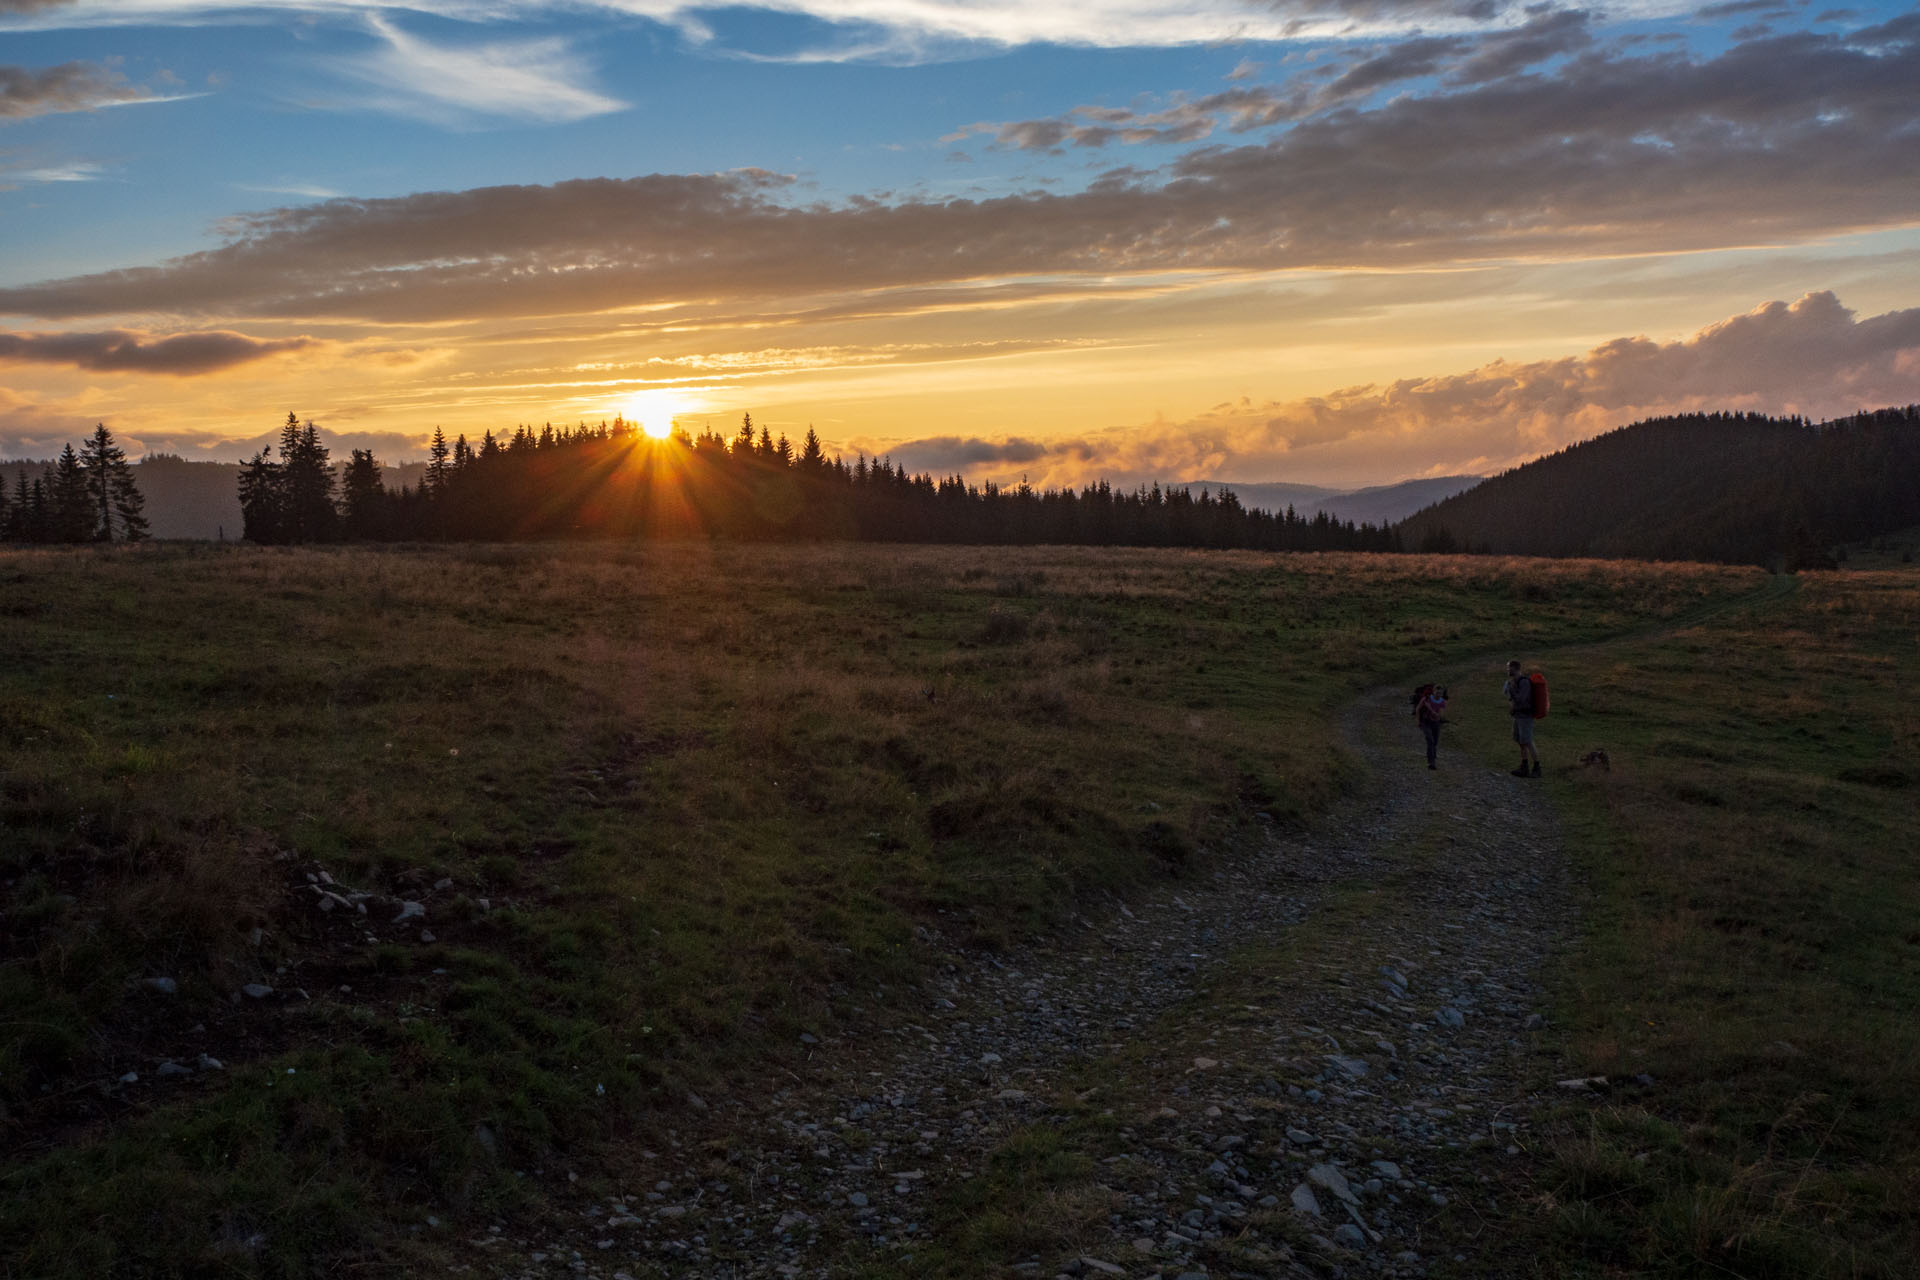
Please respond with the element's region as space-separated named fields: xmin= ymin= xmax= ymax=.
xmin=240 ymin=415 xmax=1398 ymax=551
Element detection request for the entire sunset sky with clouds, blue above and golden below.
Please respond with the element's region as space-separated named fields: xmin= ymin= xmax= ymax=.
xmin=0 ymin=0 xmax=1920 ymax=487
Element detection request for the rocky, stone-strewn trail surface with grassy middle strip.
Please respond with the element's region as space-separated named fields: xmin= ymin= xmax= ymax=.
xmin=463 ymin=691 xmax=1574 ymax=1280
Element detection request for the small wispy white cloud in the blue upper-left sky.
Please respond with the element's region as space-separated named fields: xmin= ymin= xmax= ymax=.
xmin=323 ymin=15 xmax=626 ymax=125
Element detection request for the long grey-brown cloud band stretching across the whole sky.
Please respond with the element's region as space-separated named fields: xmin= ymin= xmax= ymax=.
xmin=0 ymin=27 xmax=1920 ymax=320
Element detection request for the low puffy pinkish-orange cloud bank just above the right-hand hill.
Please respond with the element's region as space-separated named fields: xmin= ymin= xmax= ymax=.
xmin=871 ymin=292 xmax=1920 ymax=484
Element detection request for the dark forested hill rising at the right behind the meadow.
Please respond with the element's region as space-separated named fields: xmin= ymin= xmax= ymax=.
xmin=1398 ymin=405 xmax=1920 ymax=568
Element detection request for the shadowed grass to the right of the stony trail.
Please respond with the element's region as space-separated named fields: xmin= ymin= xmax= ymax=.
xmin=1451 ymin=568 xmax=1920 ymax=1280
